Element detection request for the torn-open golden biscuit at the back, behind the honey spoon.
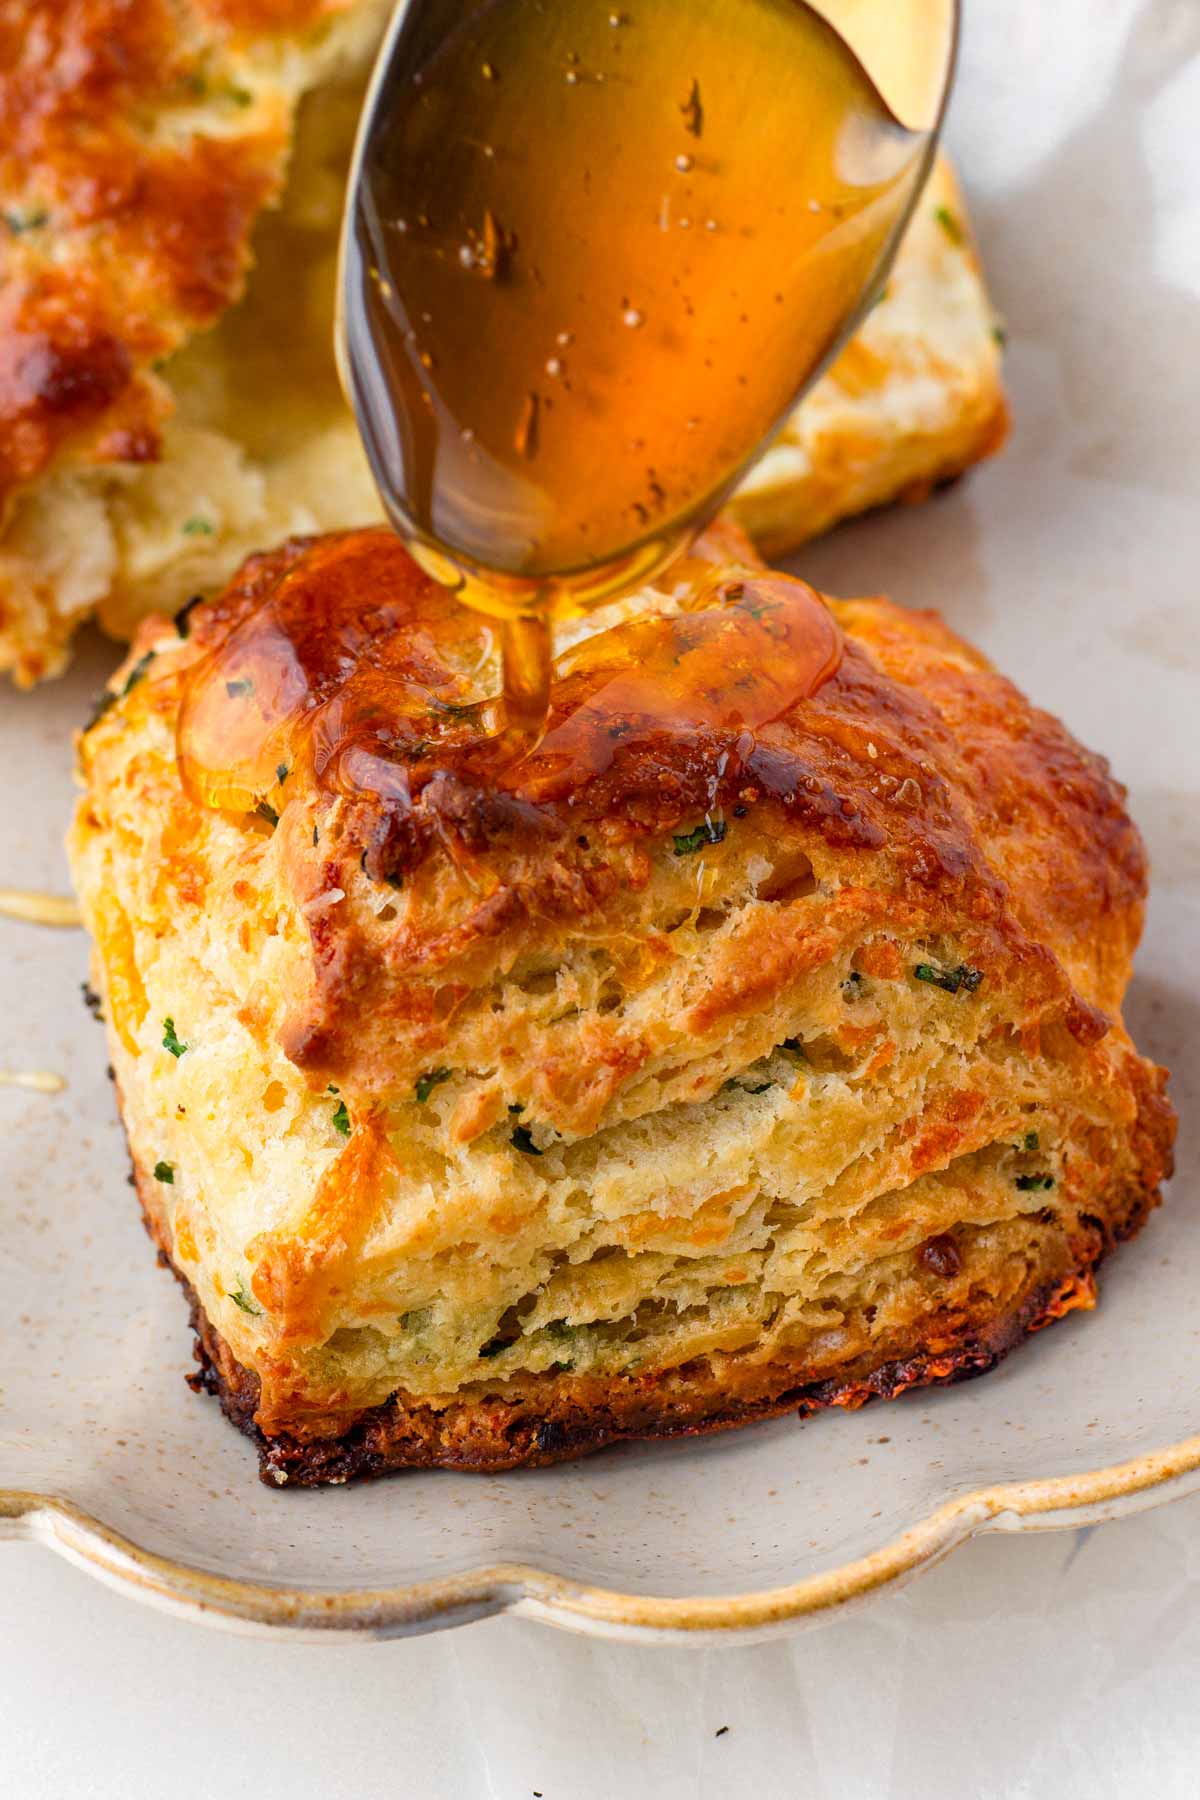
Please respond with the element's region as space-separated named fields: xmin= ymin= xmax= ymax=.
xmin=0 ymin=0 xmax=1006 ymax=684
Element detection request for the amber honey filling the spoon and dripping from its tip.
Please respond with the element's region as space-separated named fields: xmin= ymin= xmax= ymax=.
xmin=340 ymin=0 xmax=932 ymax=745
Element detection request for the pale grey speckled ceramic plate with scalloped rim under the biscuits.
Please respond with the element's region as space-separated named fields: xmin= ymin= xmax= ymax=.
xmin=0 ymin=0 xmax=1200 ymax=1634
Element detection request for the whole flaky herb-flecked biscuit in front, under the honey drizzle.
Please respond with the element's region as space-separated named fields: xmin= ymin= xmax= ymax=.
xmin=70 ymin=527 xmax=1173 ymax=1481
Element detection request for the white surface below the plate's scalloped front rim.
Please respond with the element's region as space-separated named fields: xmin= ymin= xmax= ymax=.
xmin=0 ymin=1499 xmax=1200 ymax=1800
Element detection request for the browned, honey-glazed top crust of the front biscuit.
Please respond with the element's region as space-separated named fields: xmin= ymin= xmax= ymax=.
xmin=176 ymin=529 xmax=1144 ymax=914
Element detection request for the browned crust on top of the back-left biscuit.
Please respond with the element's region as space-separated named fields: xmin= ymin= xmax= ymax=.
xmin=0 ymin=0 xmax=354 ymax=508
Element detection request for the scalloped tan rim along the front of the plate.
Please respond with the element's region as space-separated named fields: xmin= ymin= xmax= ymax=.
xmin=0 ymin=1436 xmax=1200 ymax=1643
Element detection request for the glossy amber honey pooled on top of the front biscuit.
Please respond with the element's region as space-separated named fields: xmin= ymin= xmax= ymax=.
xmin=178 ymin=531 xmax=842 ymax=821
